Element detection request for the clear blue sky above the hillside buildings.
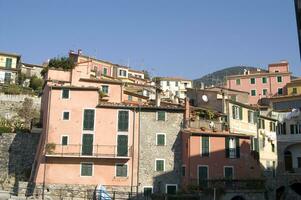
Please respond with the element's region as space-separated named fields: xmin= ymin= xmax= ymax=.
xmin=0 ymin=0 xmax=301 ymax=79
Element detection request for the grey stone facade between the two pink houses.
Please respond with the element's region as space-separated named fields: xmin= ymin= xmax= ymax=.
xmin=139 ymin=111 xmax=183 ymax=193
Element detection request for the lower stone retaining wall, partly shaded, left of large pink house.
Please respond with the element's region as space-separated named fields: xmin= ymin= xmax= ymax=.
xmin=0 ymin=133 xmax=40 ymax=190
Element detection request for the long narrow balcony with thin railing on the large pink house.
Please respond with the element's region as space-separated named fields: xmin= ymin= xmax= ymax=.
xmin=45 ymin=143 xmax=132 ymax=159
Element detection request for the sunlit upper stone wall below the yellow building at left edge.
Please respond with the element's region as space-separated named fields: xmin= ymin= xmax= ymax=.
xmin=0 ymin=93 xmax=41 ymax=118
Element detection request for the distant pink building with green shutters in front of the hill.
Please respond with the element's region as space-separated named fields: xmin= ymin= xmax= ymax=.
xmin=226 ymin=61 xmax=291 ymax=104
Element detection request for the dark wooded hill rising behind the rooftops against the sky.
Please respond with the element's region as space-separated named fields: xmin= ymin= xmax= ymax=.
xmin=193 ymin=66 xmax=263 ymax=87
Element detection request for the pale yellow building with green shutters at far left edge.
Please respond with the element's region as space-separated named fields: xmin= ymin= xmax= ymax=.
xmin=0 ymin=52 xmax=21 ymax=84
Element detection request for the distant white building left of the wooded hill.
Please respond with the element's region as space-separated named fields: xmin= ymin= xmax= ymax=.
xmin=154 ymin=77 xmax=192 ymax=99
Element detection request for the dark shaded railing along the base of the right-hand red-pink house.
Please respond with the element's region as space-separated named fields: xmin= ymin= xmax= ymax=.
xmin=189 ymin=179 xmax=265 ymax=191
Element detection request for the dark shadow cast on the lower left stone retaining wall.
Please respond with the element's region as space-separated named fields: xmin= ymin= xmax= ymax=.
xmin=8 ymin=133 xmax=40 ymax=194
